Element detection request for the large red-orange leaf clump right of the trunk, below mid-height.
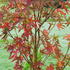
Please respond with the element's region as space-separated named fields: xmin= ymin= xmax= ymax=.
xmin=41 ymin=41 xmax=61 ymax=59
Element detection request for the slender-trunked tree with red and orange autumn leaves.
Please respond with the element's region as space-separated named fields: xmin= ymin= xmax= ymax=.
xmin=0 ymin=0 xmax=70 ymax=70
